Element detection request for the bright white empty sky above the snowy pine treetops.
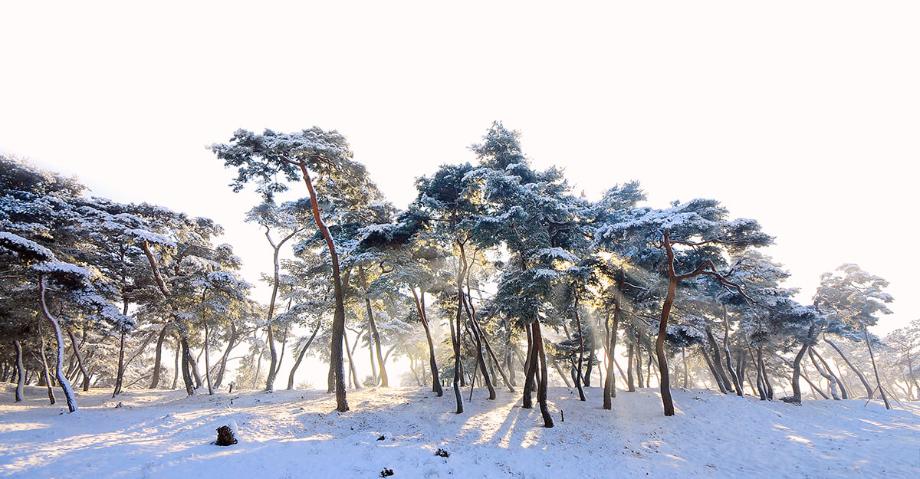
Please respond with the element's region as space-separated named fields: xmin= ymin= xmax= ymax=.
xmin=0 ymin=0 xmax=920 ymax=333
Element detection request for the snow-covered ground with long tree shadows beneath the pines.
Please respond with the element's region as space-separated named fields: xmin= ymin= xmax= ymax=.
xmin=0 ymin=385 xmax=920 ymax=479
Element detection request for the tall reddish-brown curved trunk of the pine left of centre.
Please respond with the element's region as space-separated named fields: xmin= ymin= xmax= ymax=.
xmin=299 ymin=163 xmax=348 ymax=412
